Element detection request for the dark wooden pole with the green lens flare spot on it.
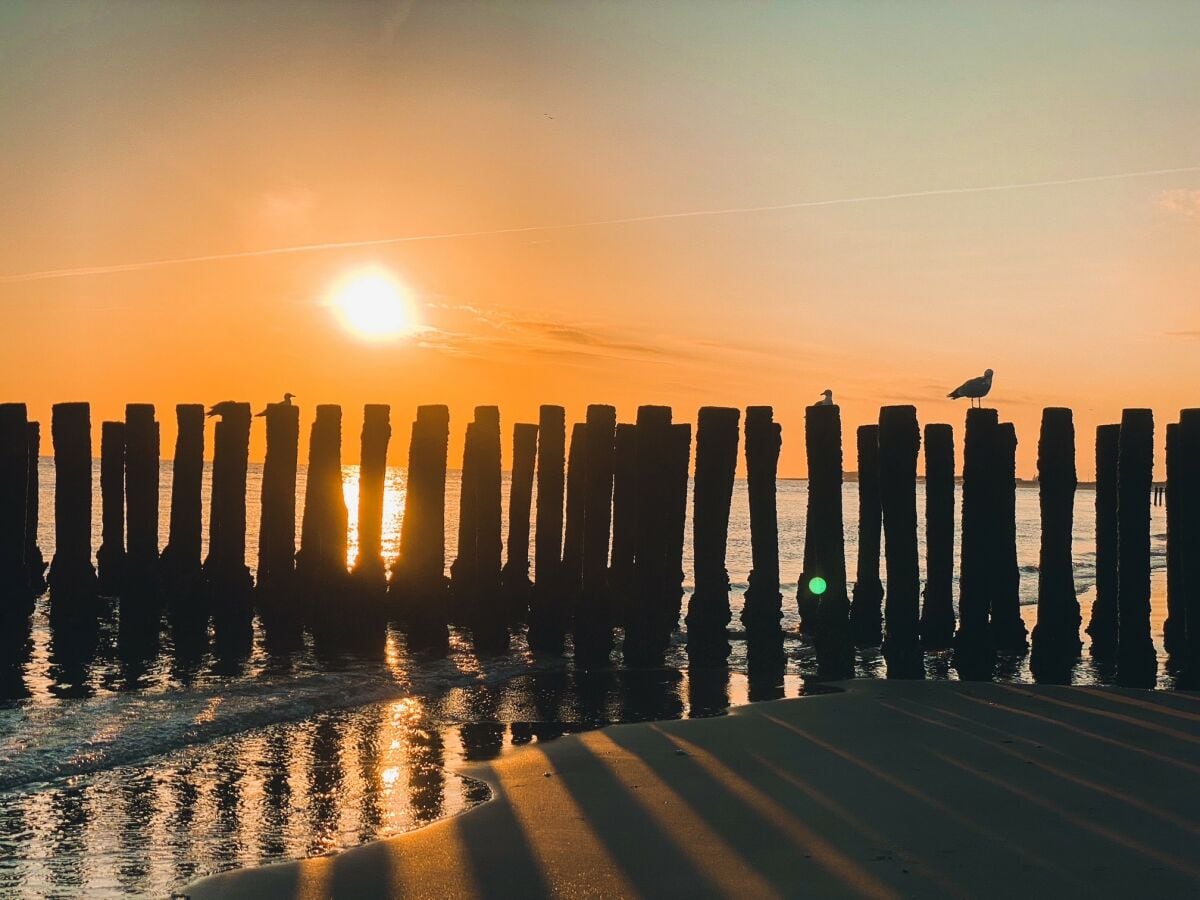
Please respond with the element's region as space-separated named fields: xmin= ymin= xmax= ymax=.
xmin=796 ymin=406 xmax=854 ymax=678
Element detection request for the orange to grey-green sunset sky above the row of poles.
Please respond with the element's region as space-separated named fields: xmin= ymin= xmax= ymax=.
xmin=0 ymin=0 xmax=1200 ymax=478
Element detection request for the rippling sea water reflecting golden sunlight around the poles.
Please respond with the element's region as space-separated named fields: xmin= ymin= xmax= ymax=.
xmin=0 ymin=460 xmax=1166 ymax=896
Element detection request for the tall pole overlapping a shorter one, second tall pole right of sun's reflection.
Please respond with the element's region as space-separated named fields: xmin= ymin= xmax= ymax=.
xmin=469 ymin=407 xmax=509 ymax=650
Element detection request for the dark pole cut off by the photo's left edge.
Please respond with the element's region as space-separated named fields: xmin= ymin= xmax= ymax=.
xmin=0 ymin=403 xmax=28 ymax=617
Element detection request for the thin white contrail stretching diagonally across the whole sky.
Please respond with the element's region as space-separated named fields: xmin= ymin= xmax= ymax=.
xmin=0 ymin=166 xmax=1200 ymax=283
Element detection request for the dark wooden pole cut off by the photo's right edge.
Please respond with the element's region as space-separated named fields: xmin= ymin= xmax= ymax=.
xmin=1176 ymin=409 xmax=1200 ymax=690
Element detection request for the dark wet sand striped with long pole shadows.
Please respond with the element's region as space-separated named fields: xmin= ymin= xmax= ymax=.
xmin=184 ymin=680 xmax=1200 ymax=900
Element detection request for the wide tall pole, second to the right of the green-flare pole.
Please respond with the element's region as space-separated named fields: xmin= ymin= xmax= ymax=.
xmin=880 ymin=406 xmax=925 ymax=678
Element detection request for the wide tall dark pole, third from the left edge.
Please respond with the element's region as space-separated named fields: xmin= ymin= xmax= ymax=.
xmin=48 ymin=403 xmax=96 ymax=609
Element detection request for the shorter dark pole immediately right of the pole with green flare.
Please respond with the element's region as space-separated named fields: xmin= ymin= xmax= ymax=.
xmin=850 ymin=425 xmax=883 ymax=647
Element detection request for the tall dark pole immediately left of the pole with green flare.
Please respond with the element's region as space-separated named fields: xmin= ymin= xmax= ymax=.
xmin=742 ymin=407 xmax=784 ymax=654
